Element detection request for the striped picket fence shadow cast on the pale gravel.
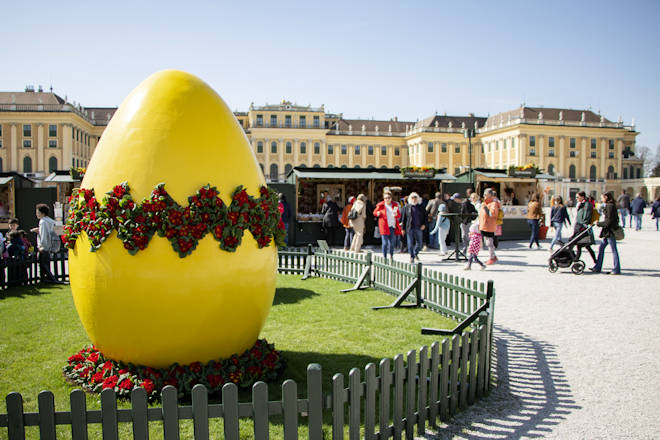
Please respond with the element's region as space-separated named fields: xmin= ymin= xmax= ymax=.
xmin=427 ymin=326 xmax=581 ymax=440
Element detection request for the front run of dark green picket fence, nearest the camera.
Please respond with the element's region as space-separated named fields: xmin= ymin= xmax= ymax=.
xmin=0 ymin=326 xmax=490 ymax=440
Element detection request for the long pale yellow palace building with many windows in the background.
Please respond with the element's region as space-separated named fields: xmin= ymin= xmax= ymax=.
xmin=0 ymin=87 xmax=642 ymax=186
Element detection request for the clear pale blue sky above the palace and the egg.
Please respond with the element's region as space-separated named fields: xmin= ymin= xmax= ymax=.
xmin=5 ymin=0 xmax=660 ymax=148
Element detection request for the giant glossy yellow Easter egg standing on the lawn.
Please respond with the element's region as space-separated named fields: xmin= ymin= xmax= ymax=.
xmin=69 ymin=70 xmax=277 ymax=367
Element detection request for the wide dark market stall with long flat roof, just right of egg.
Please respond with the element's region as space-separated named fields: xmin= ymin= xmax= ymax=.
xmin=287 ymin=167 xmax=454 ymax=245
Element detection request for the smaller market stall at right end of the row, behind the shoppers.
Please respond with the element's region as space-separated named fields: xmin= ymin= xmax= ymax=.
xmin=456 ymin=168 xmax=552 ymax=240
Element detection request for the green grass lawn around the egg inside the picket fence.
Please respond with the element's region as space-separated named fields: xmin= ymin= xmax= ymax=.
xmin=0 ymin=275 xmax=456 ymax=439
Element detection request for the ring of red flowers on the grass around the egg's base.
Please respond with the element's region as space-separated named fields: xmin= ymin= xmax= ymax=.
xmin=62 ymin=339 xmax=285 ymax=401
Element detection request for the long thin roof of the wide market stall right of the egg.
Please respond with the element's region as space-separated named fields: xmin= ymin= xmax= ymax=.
xmin=287 ymin=167 xmax=456 ymax=180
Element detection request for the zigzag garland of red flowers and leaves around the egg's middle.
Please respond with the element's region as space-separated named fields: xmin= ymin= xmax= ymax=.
xmin=63 ymin=182 xmax=285 ymax=258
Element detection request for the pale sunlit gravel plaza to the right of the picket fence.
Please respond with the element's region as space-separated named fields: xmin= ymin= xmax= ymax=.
xmin=364 ymin=217 xmax=660 ymax=439
